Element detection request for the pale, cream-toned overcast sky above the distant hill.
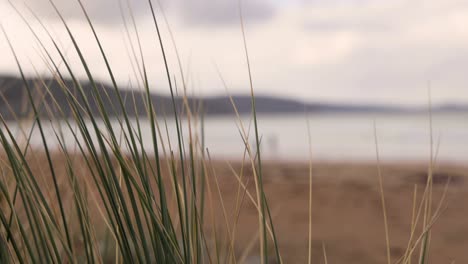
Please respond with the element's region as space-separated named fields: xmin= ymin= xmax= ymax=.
xmin=0 ymin=0 xmax=468 ymax=104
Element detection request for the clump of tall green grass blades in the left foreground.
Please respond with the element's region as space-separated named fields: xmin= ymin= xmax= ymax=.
xmin=0 ymin=0 xmax=281 ymax=263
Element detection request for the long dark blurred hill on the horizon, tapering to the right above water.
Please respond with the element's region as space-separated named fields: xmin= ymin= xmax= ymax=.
xmin=0 ymin=76 xmax=468 ymax=119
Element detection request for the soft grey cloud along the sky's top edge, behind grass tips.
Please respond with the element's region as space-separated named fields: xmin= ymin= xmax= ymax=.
xmin=8 ymin=0 xmax=276 ymax=26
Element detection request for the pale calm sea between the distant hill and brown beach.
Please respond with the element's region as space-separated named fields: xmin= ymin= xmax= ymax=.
xmin=2 ymin=112 xmax=468 ymax=163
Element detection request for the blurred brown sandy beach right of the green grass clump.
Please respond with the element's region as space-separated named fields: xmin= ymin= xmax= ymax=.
xmin=3 ymin=152 xmax=468 ymax=263
